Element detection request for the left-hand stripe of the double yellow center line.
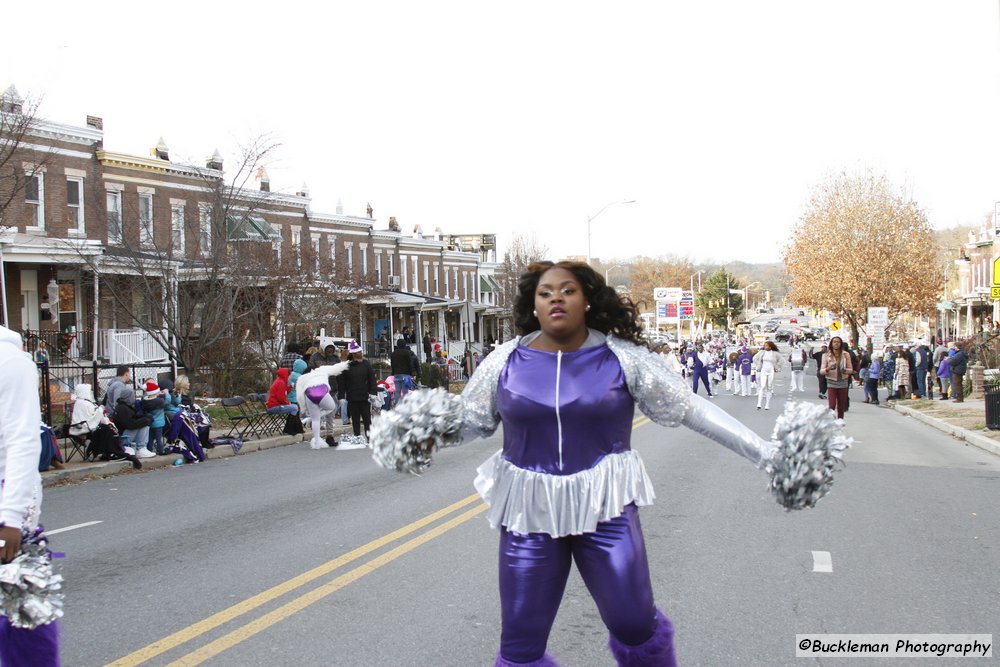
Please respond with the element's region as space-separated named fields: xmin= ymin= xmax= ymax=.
xmin=108 ymin=493 xmax=485 ymax=667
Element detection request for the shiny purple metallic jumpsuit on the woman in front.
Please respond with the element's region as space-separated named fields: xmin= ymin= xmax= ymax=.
xmin=496 ymin=344 xmax=672 ymax=663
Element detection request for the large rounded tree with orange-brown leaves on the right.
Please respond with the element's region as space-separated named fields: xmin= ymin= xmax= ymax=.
xmin=783 ymin=173 xmax=943 ymax=350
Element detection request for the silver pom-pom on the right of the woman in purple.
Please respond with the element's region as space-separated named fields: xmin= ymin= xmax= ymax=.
xmin=767 ymin=402 xmax=852 ymax=510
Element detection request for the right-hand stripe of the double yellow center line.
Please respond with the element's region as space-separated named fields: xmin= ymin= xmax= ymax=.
xmin=167 ymin=504 xmax=486 ymax=667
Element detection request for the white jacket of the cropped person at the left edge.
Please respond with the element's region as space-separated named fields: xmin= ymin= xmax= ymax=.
xmin=0 ymin=326 xmax=42 ymax=529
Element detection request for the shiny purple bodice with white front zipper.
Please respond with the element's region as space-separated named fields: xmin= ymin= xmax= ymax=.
xmin=496 ymin=344 xmax=635 ymax=475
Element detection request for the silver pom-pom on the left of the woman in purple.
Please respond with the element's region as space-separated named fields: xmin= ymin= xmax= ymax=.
xmin=371 ymin=388 xmax=463 ymax=474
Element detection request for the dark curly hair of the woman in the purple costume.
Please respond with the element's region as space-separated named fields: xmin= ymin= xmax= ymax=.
xmin=514 ymin=262 xmax=646 ymax=345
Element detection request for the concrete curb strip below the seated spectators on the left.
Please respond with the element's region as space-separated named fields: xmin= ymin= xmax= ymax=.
xmin=41 ymin=423 xmax=364 ymax=487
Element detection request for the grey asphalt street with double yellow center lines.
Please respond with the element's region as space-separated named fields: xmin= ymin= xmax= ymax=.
xmin=43 ymin=370 xmax=1000 ymax=667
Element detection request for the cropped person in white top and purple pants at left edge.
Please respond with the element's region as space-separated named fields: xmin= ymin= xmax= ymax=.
xmin=0 ymin=326 xmax=59 ymax=667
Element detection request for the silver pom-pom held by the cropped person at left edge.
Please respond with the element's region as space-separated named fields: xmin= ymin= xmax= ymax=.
xmin=0 ymin=531 xmax=63 ymax=629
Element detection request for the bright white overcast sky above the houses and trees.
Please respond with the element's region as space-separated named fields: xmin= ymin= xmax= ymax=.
xmin=7 ymin=0 xmax=1000 ymax=263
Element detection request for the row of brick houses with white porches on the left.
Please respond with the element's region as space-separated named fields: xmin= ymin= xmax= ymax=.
xmin=0 ymin=88 xmax=510 ymax=370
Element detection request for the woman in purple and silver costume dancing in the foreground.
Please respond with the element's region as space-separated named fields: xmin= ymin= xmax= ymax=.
xmin=372 ymin=262 xmax=846 ymax=667
